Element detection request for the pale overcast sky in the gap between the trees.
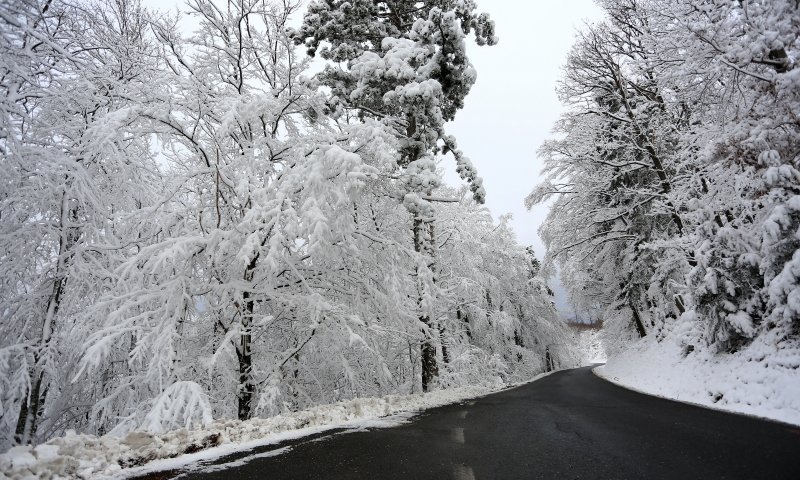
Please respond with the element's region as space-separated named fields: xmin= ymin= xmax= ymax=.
xmin=445 ymin=0 xmax=601 ymax=314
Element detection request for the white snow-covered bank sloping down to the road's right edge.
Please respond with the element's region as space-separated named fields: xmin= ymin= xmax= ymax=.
xmin=594 ymin=328 xmax=800 ymax=425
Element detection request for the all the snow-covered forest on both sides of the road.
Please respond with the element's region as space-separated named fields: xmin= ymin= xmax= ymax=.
xmin=0 ymin=0 xmax=800 ymax=468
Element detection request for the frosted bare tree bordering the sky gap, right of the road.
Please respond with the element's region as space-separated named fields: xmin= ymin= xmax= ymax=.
xmin=528 ymin=0 xmax=695 ymax=344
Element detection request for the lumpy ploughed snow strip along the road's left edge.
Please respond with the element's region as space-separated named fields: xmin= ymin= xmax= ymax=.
xmin=0 ymin=374 xmax=547 ymax=479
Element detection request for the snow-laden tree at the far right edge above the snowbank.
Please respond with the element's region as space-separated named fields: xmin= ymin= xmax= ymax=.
xmin=654 ymin=0 xmax=800 ymax=350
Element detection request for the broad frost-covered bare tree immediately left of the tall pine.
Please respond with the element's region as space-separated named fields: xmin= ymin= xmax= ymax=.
xmin=74 ymin=0 xmax=390 ymax=427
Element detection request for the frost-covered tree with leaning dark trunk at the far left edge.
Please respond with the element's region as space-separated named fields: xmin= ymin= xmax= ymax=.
xmin=0 ymin=1 xmax=159 ymax=444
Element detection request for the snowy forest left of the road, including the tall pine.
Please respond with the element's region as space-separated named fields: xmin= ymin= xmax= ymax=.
xmin=0 ymin=0 xmax=574 ymax=449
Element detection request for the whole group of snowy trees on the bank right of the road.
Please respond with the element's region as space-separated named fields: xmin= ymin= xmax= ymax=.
xmin=529 ymin=0 xmax=800 ymax=351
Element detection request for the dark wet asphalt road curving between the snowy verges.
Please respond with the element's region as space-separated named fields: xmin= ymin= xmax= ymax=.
xmin=164 ymin=368 xmax=800 ymax=480
